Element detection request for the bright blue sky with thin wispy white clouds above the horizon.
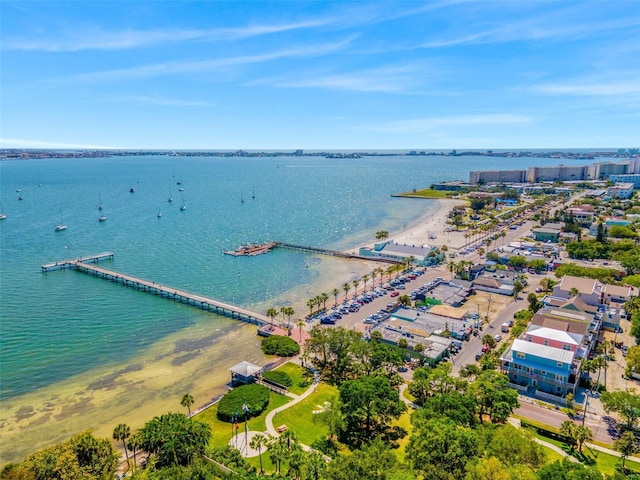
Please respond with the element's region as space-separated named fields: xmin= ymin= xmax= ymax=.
xmin=0 ymin=0 xmax=640 ymax=150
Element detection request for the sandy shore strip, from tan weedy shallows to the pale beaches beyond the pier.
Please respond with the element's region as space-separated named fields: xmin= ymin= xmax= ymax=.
xmin=0 ymin=199 xmax=460 ymax=464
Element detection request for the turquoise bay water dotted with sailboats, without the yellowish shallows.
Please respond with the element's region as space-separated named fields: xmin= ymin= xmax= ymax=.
xmin=0 ymin=156 xmax=596 ymax=400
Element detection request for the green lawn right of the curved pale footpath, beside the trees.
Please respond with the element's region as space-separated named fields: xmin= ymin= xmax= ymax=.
xmin=273 ymin=383 xmax=338 ymax=445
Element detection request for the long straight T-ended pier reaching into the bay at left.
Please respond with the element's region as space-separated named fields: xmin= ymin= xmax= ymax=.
xmin=42 ymin=253 xmax=269 ymax=326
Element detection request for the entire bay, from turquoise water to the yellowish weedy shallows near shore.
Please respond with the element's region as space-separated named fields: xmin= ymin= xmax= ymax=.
xmin=0 ymin=156 xmax=591 ymax=464
